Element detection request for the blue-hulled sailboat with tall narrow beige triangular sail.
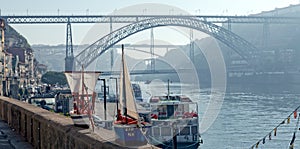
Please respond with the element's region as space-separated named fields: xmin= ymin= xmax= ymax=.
xmin=113 ymin=45 xmax=150 ymax=147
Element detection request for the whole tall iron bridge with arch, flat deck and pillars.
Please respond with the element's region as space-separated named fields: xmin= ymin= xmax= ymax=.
xmin=0 ymin=15 xmax=300 ymax=70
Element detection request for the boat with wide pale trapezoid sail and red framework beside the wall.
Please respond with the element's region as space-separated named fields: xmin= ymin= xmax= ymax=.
xmin=65 ymin=66 xmax=100 ymax=130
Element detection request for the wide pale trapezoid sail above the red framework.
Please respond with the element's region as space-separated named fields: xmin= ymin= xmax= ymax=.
xmin=65 ymin=71 xmax=100 ymax=95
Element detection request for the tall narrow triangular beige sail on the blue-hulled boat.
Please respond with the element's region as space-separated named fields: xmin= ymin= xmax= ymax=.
xmin=119 ymin=46 xmax=139 ymax=119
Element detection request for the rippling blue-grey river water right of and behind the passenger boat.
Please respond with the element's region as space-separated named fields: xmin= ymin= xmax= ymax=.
xmin=137 ymin=84 xmax=300 ymax=149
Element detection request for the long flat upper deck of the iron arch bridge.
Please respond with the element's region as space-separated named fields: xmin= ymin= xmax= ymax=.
xmin=0 ymin=15 xmax=300 ymax=24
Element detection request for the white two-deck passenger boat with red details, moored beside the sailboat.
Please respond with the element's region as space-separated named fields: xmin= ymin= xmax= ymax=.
xmin=148 ymin=80 xmax=203 ymax=149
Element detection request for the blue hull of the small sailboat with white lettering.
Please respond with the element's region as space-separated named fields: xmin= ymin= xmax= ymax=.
xmin=113 ymin=124 xmax=148 ymax=146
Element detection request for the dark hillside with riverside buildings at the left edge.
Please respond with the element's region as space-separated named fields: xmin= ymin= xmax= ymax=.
xmin=0 ymin=19 xmax=47 ymax=98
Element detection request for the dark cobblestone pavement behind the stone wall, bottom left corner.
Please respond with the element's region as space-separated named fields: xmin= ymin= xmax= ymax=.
xmin=0 ymin=120 xmax=33 ymax=149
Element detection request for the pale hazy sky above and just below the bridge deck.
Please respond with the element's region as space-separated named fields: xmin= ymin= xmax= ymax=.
xmin=0 ymin=0 xmax=299 ymax=45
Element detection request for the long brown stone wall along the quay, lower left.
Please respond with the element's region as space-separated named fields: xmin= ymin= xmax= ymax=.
xmin=0 ymin=97 xmax=126 ymax=149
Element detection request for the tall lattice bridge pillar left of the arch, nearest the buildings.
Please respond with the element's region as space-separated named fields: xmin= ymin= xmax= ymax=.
xmin=65 ymin=22 xmax=74 ymax=71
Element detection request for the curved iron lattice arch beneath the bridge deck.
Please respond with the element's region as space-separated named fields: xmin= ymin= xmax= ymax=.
xmin=75 ymin=17 xmax=258 ymax=69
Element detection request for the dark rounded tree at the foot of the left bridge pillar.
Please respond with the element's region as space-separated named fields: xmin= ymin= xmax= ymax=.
xmin=42 ymin=71 xmax=68 ymax=85
